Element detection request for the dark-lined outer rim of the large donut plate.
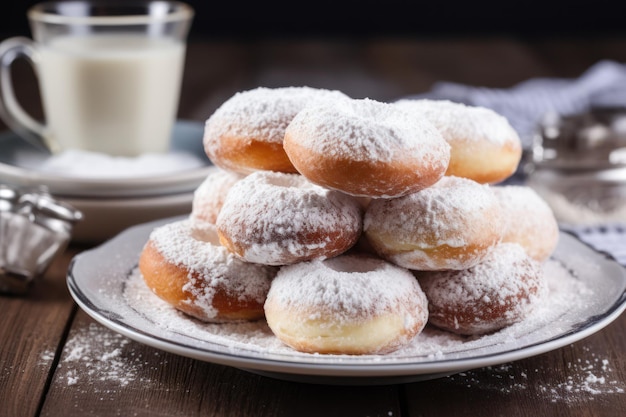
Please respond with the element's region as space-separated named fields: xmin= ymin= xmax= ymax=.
xmin=67 ymin=216 xmax=626 ymax=383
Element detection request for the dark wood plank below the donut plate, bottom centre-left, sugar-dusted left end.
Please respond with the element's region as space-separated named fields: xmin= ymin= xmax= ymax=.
xmin=41 ymin=311 xmax=400 ymax=417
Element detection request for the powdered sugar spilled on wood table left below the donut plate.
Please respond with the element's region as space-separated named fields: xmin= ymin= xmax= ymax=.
xmin=42 ymin=323 xmax=160 ymax=391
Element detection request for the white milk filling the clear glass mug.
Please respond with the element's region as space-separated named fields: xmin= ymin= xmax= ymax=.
xmin=38 ymin=34 xmax=185 ymax=155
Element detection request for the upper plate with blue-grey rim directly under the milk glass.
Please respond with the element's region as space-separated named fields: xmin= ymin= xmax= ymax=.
xmin=0 ymin=120 xmax=212 ymax=198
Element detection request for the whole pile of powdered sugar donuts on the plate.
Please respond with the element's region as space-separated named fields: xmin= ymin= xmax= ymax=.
xmin=139 ymin=87 xmax=558 ymax=354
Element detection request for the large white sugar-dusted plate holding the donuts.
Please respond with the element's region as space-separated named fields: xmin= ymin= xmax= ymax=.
xmin=67 ymin=217 xmax=626 ymax=385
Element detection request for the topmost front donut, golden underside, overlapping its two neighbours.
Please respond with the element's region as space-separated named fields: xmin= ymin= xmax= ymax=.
xmin=284 ymin=99 xmax=450 ymax=198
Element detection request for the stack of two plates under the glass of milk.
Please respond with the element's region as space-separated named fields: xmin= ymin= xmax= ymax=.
xmin=0 ymin=121 xmax=213 ymax=243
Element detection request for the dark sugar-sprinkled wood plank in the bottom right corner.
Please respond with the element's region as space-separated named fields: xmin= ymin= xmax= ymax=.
xmin=402 ymin=315 xmax=626 ymax=417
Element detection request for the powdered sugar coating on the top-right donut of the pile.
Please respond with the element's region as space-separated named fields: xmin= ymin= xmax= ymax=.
xmin=394 ymin=99 xmax=521 ymax=146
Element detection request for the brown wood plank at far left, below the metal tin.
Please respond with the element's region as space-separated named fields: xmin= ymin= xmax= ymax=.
xmin=0 ymin=248 xmax=78 ymax=417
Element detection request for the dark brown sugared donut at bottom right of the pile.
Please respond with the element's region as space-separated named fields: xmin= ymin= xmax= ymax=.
xmin=416 ymin=243 xmax=547 ymax=335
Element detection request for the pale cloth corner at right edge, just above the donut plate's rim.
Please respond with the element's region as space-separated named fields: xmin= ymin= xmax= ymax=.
xmin=564 ymin=224 xmax=626 ymax=266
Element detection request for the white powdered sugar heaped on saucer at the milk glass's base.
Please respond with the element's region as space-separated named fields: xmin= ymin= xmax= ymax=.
xmin=28 ymin=150 xmax=205 ymax=179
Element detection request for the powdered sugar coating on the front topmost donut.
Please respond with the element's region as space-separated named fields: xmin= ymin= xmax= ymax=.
xmin=286 ymin=99 xmax=450 ymax=165
